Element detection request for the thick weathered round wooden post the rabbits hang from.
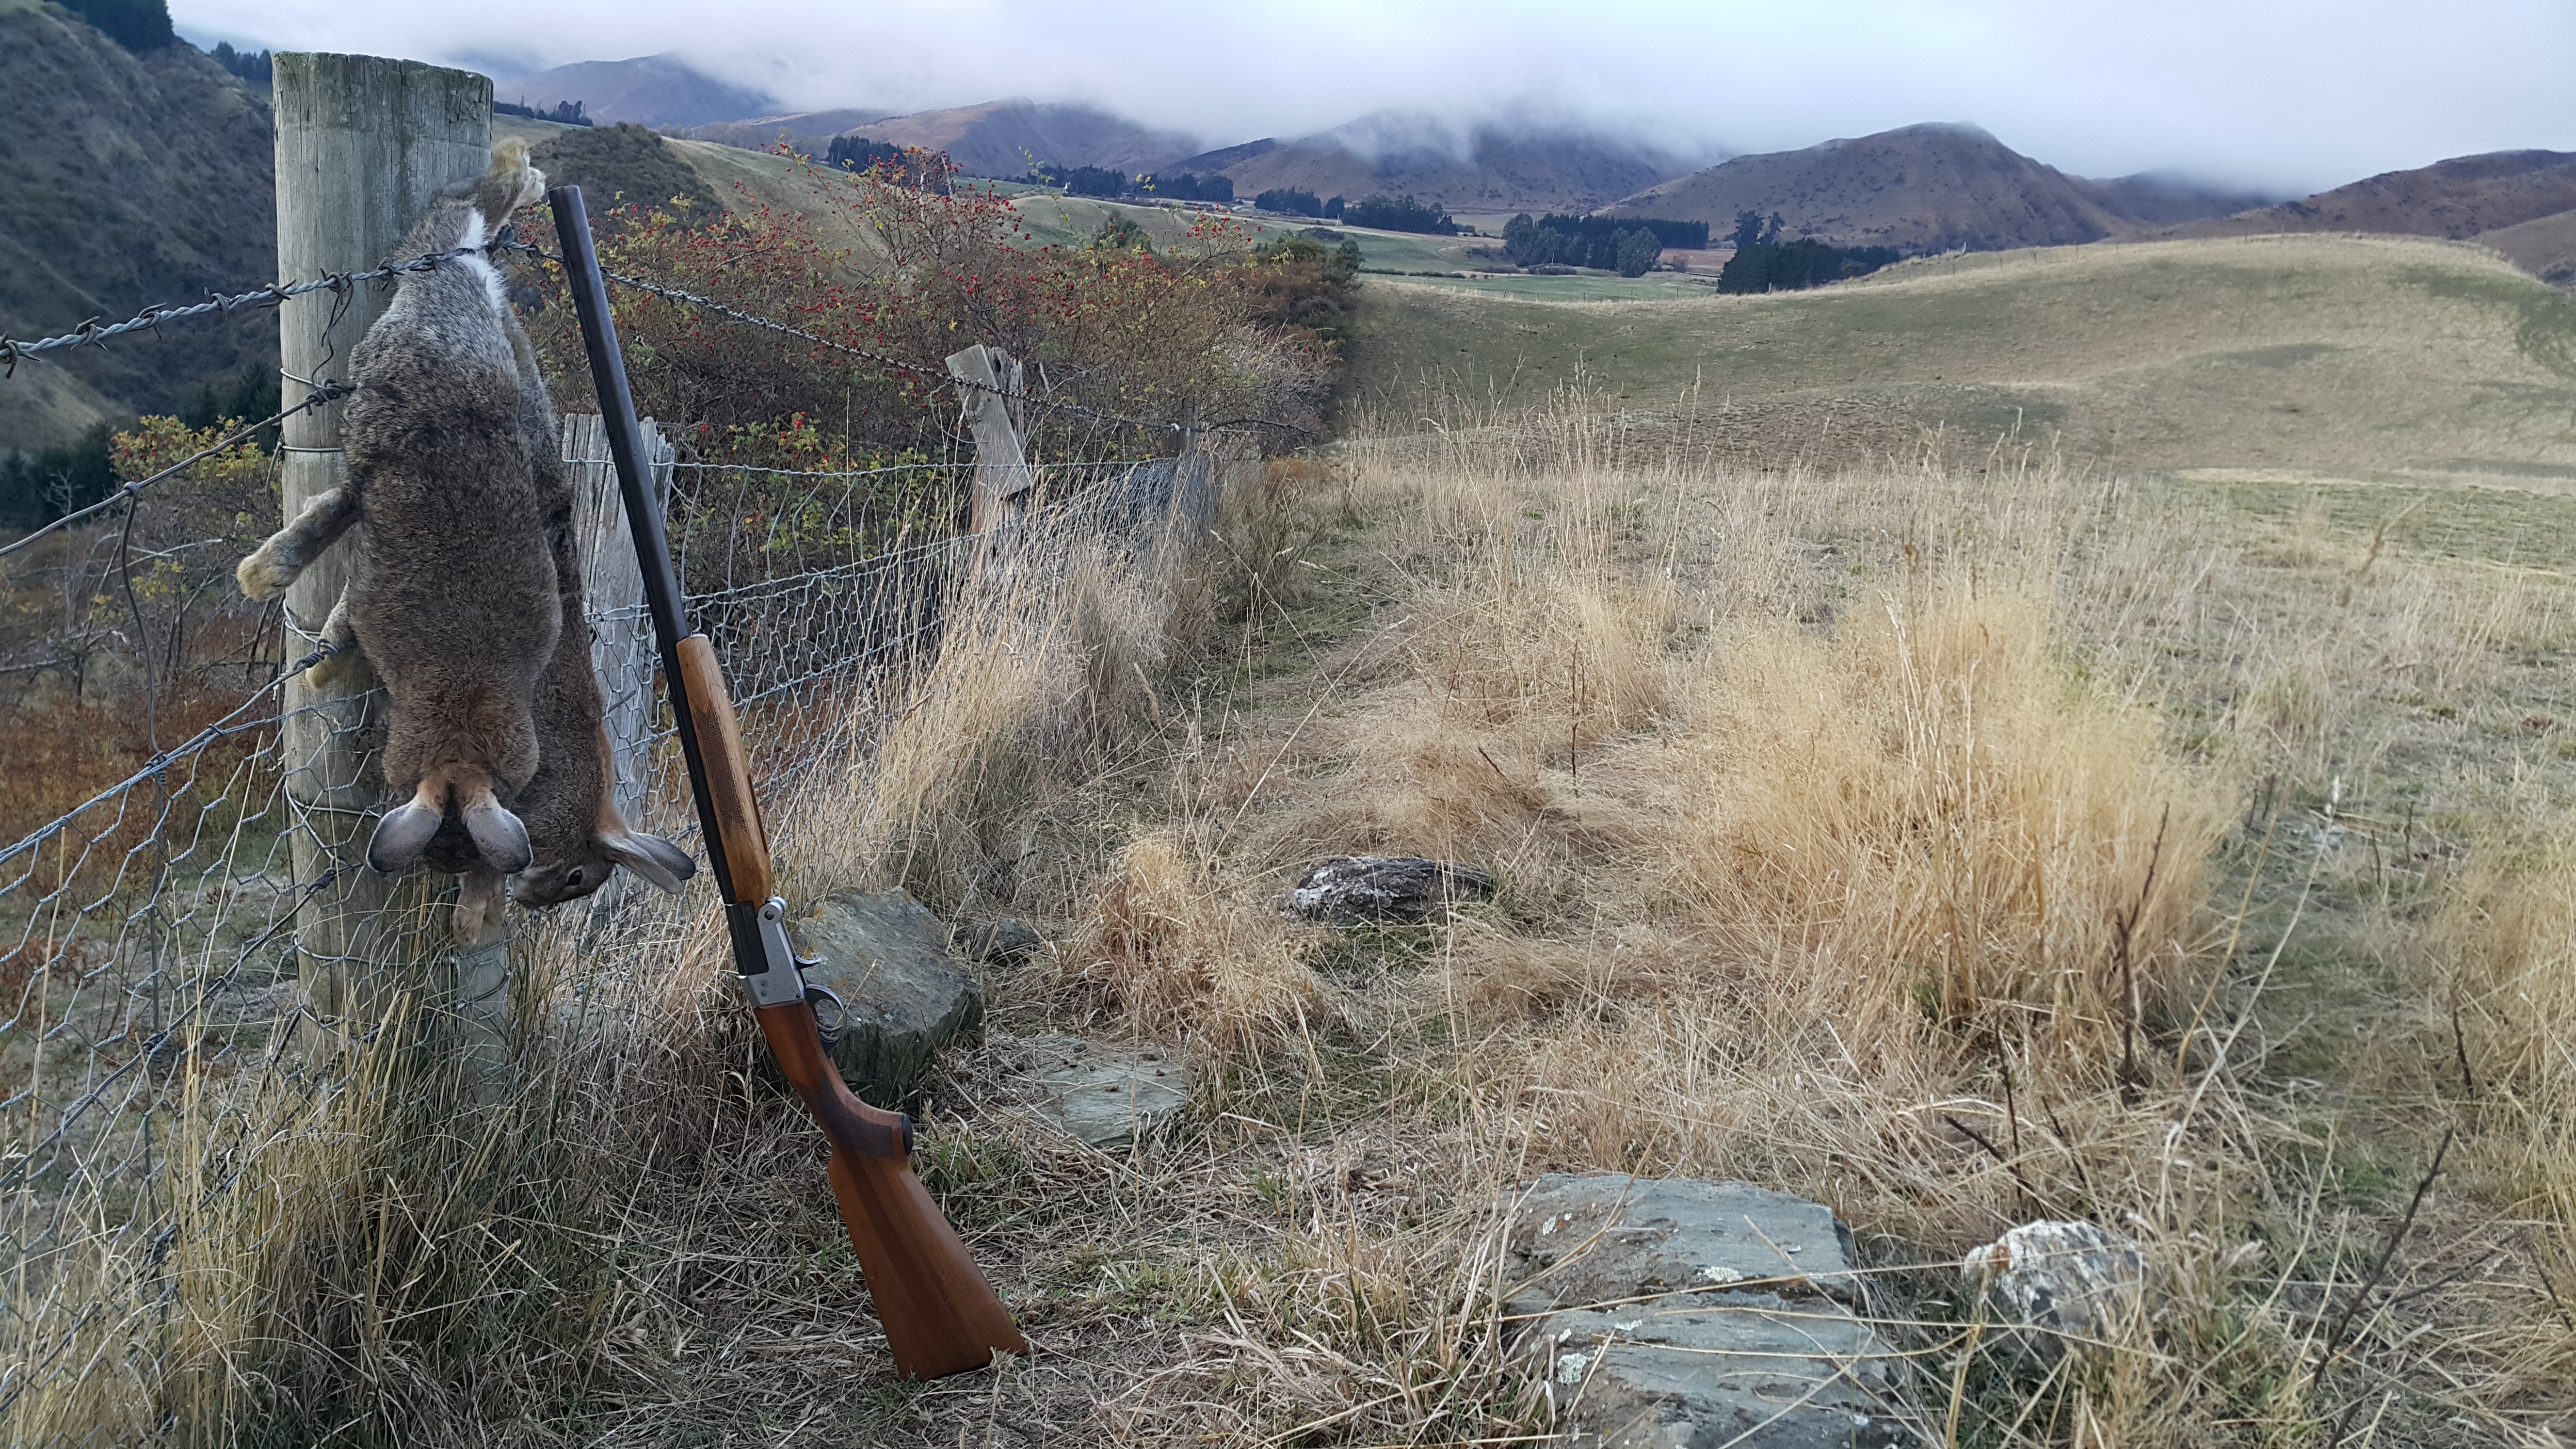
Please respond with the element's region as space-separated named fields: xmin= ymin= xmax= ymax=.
xmin=273 ymin=54 xmax=492 ymax=1018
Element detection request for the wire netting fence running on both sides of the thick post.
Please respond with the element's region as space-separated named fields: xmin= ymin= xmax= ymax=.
xmin=0 ymin=407 xmax=1224 ymax=1444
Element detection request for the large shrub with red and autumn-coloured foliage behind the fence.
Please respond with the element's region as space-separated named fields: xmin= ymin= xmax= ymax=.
xmin=515 ymin=162 xmax=1329 ymax=471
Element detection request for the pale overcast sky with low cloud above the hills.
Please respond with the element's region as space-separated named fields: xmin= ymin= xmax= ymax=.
xmin=170 ymin=0 xmax=2576 ymax=193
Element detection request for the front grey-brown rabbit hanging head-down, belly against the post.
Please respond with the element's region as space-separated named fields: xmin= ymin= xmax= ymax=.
xmin=240 ymin=142 xmax=572 ymax=874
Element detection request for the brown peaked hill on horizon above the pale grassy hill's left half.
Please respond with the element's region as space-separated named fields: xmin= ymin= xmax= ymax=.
xmin=1605 ymin=124 xmax=2262 ymax=253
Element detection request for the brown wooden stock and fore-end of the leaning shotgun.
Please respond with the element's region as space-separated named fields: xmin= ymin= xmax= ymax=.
xmin=677 ymin=634 xmax=1028 ymax=1379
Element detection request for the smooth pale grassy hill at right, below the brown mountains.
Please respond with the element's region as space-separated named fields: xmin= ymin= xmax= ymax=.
xmin=1352 ymin=237 xmax=2576 ymax=485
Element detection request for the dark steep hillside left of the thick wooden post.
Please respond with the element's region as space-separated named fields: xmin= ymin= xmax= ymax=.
xmin=0 ymin=2 xmax=278 ymax=446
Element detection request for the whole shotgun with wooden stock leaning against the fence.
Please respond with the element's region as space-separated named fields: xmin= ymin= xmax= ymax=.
xmin=546 ymin=186 xmax=1028 ymax=1379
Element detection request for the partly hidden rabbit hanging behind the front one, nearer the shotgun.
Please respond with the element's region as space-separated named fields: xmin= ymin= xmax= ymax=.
xmin=240 ymin=152 xmax=695 ymax=941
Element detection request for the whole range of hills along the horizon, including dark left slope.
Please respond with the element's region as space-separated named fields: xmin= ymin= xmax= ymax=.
xmin=0 ymin=16 xmax=2576 ymax=446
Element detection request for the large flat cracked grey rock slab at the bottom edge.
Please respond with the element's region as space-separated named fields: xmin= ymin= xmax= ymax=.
xmin=1504 ymin=1173 xmax=1914 ymax=1449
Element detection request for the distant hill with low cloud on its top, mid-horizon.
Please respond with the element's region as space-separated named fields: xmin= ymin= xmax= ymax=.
xmin=1172 ymin=111 xmax=1685 ymax=214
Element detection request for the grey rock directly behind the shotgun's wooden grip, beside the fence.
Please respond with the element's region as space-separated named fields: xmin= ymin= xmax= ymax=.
xmin=788 ymin=889 xmax=984 ymax=1106
